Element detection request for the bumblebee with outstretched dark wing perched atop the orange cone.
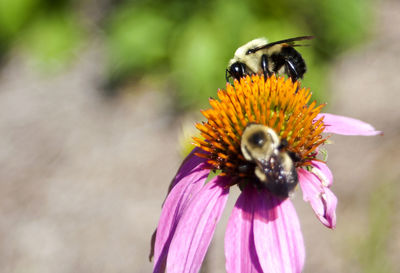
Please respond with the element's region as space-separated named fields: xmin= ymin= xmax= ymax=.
xmin=225 ymin=36 xmax=314 ymax=82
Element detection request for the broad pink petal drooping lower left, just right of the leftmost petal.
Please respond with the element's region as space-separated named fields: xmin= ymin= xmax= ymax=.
xmin=167 ymin=176 xmax=230 ymax=273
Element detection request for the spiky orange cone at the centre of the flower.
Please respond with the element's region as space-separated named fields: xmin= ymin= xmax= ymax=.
xmin=193 ymin=75 xmax=326 ymax=182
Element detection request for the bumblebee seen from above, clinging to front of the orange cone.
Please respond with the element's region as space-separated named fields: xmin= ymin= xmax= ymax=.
xmin=240 ymin=123 xmax=298 ymax=198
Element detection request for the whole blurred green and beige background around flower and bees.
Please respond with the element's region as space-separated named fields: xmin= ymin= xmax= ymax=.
xmin=0 ymin=0 xmax=400 ymax=273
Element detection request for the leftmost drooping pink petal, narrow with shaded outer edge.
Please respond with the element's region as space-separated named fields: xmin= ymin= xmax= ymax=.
xmin=154 ymin=159 xmax=210 ymax=272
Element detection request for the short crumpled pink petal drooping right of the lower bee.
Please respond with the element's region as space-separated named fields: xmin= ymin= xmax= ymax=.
xmin=297 ymin=169 xmax=337 ymax=228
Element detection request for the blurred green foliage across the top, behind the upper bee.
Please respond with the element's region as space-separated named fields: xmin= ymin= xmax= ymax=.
xmin=0 ymin=0 xmax=374 ymax=106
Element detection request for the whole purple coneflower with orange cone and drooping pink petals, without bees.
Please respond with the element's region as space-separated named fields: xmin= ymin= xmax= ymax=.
xmin=154 ymin=76 xmax=380 ymax=273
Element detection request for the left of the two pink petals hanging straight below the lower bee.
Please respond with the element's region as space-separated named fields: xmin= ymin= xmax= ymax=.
xmin=225 ymin=188 xmax=262 ymax=273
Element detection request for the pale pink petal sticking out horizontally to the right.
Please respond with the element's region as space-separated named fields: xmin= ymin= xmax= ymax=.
xmin=315 ymin=113 xmax=382 ymax=136
